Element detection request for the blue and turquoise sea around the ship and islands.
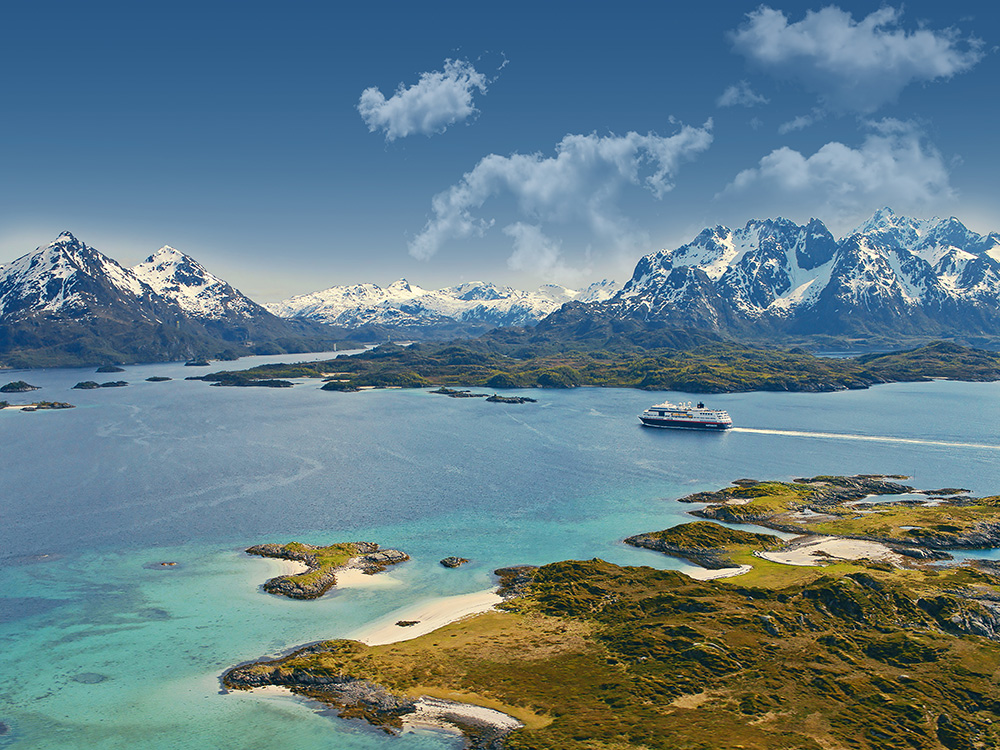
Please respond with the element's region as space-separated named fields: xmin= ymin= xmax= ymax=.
xmin=0 ymin=355 xmax=1000 ymax=750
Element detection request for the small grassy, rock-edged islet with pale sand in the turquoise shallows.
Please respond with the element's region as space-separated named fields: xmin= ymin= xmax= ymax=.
xmin=246 ymin=542 xmax=410 ymax=599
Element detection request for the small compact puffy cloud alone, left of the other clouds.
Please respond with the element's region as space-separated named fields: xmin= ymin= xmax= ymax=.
xmin=358 ymin=60 xmax=492 ymax=141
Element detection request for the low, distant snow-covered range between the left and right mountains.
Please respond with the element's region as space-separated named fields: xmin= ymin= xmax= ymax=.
xmin=265 ymin=279 xmax=617 ymax=328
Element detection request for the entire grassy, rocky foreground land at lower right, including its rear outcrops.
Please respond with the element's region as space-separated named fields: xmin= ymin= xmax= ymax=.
xmin=223 ymin=477 xmax=1000 ymax=750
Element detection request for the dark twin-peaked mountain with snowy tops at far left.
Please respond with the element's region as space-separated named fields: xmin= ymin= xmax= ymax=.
xmin=0 ymin=232 xmax=348 ymax=366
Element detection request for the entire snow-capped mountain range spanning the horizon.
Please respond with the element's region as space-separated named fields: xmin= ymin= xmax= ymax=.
xmin=0 ymin=208 xmax=1000 ymax=367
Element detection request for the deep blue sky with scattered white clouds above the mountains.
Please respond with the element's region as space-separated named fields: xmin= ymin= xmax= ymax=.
xmin=0 ymin=0 xmax=1000 ymax=302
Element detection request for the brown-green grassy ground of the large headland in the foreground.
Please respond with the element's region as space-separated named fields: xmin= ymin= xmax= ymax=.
xmin=229 ymin=560 xmax=1000 ymax=750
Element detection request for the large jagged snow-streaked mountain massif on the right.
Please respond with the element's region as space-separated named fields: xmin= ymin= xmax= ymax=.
xmin=576 ymin=208 xmax=1000 ymax=335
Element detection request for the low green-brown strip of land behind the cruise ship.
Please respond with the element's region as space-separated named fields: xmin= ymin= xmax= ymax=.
xmin=193 ymin=344 xmax=1000 ymax=393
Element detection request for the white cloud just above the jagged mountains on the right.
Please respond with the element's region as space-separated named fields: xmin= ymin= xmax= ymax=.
xmin=716 ymin=119 xmax=956 ymax=231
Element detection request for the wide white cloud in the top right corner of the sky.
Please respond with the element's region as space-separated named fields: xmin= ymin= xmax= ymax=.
xmin=731 ymin=5 xmax=983 ymax=113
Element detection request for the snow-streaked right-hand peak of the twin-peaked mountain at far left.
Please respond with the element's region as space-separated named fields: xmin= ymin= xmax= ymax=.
xmin=132 ymin=245 xmax=268 ymax=320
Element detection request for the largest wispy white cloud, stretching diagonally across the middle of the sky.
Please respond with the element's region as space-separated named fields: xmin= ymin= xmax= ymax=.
xmin=410 ymin=120 xmax=712 ymax=267
